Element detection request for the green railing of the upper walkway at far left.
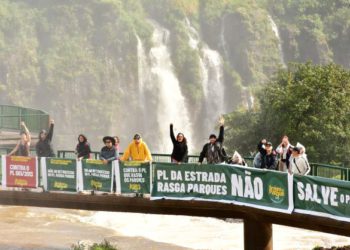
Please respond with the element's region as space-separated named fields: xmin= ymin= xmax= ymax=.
xmin=0 ymin=105 xmax=49 ymax=132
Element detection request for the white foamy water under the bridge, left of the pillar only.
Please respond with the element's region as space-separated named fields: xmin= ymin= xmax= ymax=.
xmin=82 ymin=212 xmax=243 ymax=249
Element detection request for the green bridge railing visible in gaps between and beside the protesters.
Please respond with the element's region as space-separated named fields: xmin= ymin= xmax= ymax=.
xmin=57 ymin=150 xmax=350 ymax=181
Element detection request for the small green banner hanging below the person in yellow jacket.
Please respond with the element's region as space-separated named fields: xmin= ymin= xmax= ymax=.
xmin=116 ymin=161 xmax=151 ymax=194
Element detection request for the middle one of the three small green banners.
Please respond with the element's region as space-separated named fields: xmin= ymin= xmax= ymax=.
xmin=82 ymin=159 xmax=113 ymax=192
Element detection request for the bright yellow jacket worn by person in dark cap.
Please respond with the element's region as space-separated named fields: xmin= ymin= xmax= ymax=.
xmin=120 ymin=139 xmax=152 ymax=161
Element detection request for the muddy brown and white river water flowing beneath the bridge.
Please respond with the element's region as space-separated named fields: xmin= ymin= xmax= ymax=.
xmin=0 ymin=206 xmax=350 ymax=250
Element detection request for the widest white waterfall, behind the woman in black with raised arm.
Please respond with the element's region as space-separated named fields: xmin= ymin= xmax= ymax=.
xmin=146 ymin=21 xmax=193 ymax=152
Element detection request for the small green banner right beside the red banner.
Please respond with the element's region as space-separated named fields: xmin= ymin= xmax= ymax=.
xmin=42 ymin=158 xmax=77 ymax=192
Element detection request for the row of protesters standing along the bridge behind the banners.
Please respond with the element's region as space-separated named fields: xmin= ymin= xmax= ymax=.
xmin=9 ymin=117 xmax=310 ymax=175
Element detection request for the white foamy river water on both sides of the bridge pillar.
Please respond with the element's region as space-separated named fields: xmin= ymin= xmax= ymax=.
xmin=82 ymin=212 xmax=350 ymax=250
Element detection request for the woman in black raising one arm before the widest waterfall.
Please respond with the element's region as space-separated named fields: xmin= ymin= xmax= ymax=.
xmin=170 ymin=124 xmax=188 ymax=163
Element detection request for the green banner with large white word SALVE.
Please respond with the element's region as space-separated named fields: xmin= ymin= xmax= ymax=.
xmin=293 ymin=175 xmax=350 ymax=221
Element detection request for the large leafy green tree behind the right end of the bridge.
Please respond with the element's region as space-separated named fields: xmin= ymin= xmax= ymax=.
xmin=226 ymin=63 xmax=350 ymax=164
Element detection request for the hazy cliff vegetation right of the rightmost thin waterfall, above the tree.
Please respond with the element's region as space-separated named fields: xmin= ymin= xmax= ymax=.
xmin=261 ymin=0 xmax=350 ymax=67
